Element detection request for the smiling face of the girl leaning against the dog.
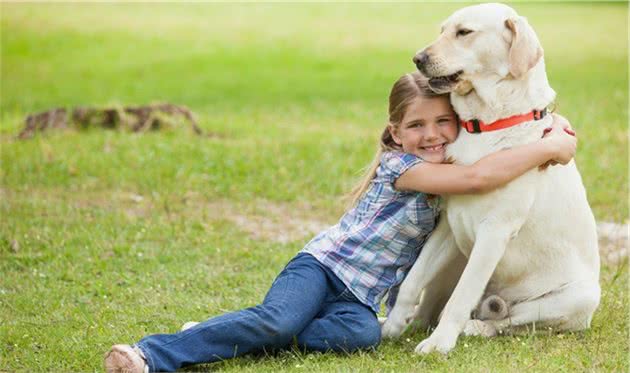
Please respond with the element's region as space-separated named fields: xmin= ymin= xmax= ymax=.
xmin=389 ymin=97 xmax=458 ymax=163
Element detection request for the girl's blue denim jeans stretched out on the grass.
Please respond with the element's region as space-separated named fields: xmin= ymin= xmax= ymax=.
xmin=136 ymin=253 xmax=381 ymax=372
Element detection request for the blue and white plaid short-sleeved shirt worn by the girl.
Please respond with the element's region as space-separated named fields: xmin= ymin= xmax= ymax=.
xmin=302 ymin=152 xmax=439 ymax=313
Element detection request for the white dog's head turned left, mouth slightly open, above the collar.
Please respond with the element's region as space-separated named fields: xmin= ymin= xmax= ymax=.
xmin=413 ymin=4 xmax=543 ymax=95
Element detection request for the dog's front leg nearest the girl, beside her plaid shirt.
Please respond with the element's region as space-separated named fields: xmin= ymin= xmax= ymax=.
xmin=381 ymin=217 xmax=460 ymax=338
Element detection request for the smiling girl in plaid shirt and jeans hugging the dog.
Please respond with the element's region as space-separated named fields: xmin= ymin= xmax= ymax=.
xmin=105 ymin=73 xmax=576 ymax=373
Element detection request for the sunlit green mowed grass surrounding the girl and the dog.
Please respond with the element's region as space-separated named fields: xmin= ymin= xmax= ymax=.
xmin=0 ymin=3 xmax=630 ymax=371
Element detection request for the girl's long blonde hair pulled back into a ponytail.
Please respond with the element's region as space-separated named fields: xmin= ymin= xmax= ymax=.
xmin=349 ymin=71 xmax=448 ymax=207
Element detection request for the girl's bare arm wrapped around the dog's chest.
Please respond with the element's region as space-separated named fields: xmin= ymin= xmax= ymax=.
xmin=394 ymin=118 xmax=577 ymax=194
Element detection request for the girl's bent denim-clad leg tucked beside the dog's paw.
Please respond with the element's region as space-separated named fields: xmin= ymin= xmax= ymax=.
xmin=297 ymin=301 xmax=381 ymax=352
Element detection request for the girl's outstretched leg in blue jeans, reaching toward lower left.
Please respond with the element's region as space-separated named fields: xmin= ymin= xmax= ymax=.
xmin=136 ymin=254 xmax=330 ymax=372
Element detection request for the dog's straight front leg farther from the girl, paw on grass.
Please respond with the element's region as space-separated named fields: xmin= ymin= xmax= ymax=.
xmin=416 ymin=222 xmax=516 ymax=354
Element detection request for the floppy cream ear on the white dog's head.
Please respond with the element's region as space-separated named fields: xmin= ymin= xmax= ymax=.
xmin=505 ymin=17 xmax=543 ymax=79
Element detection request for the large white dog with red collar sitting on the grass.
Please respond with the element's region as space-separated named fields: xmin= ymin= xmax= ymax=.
xmin=382 ymin=4 xmax=600 ymax=353
